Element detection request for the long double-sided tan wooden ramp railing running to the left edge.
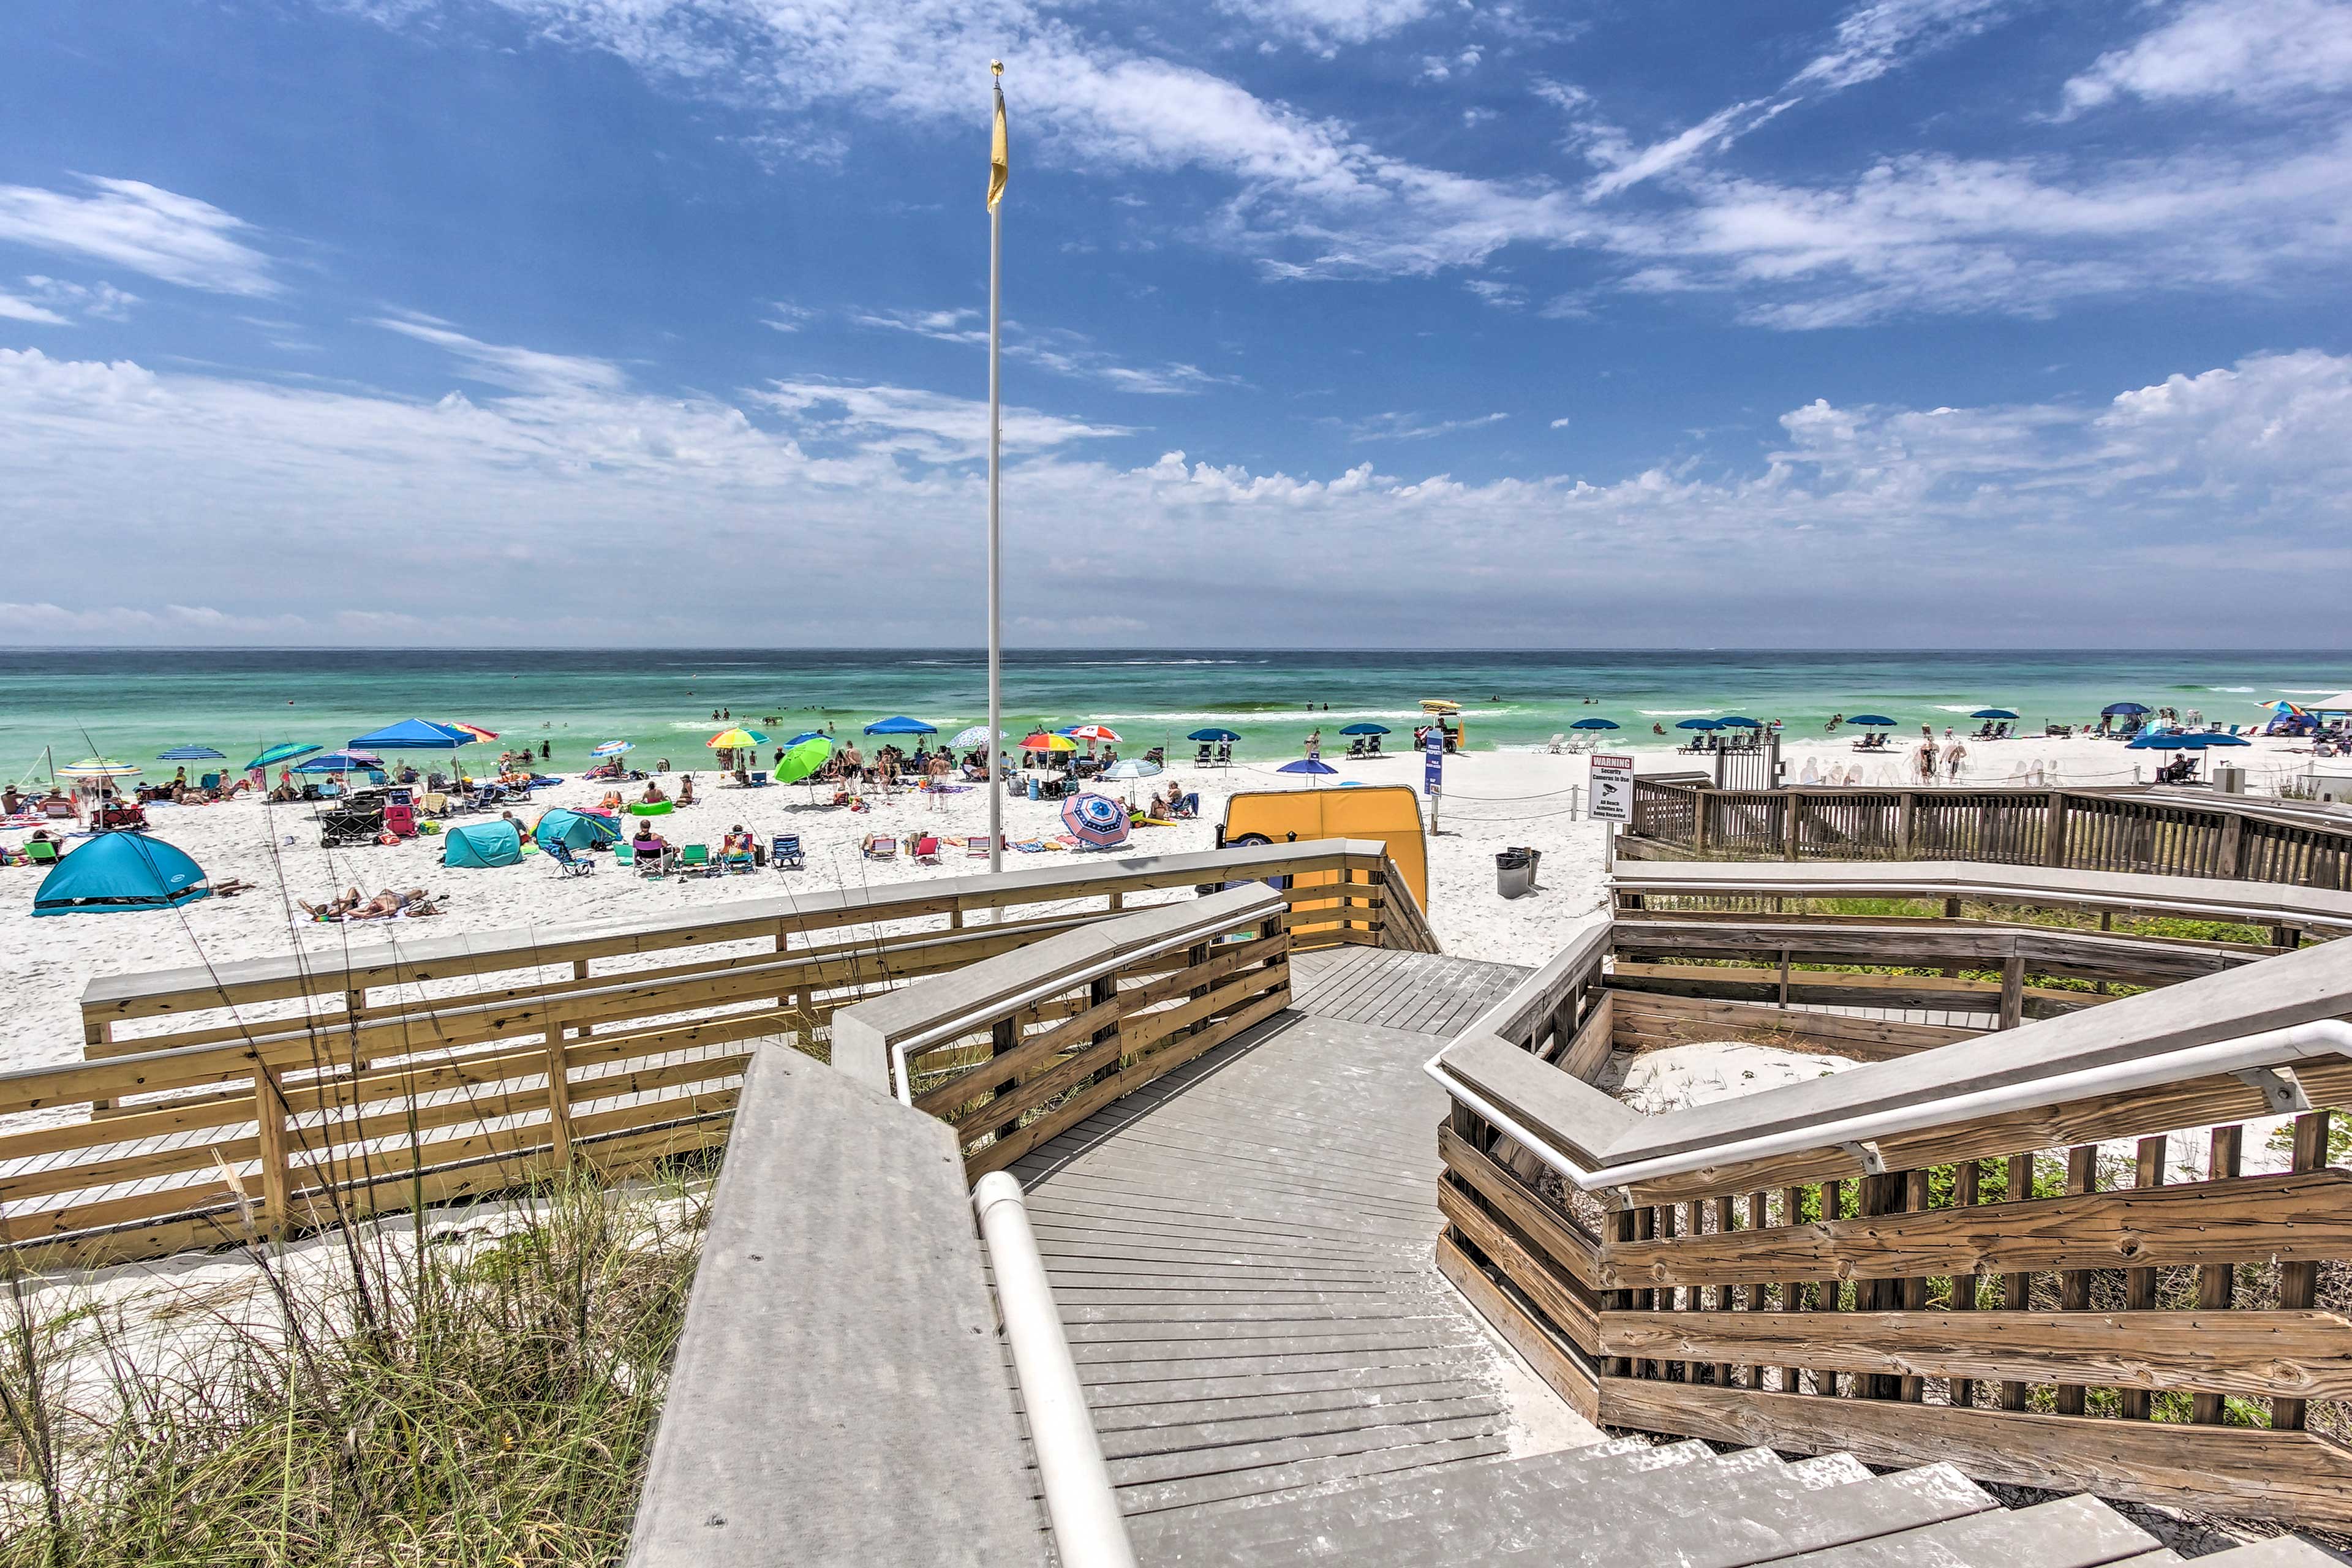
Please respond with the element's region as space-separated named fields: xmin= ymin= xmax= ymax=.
xmin=0 ymin=839 xmax=1433 ymax=1262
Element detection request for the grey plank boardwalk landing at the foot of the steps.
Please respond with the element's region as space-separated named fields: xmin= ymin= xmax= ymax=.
xmin=1014 ymin=950 xmax=1585 ymax=1514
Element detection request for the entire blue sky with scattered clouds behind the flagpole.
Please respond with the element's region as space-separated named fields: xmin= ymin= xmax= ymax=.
xmin=0 ymin=0 xmax=2352 ymax=646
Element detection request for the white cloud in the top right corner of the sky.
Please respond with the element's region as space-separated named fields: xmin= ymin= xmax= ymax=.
xmin=2065 ymin=0 xmax=2352 ymax=113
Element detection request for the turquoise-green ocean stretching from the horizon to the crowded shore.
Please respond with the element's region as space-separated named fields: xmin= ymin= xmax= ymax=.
xmin=0 ymin=649 xmax=2352 ymax=778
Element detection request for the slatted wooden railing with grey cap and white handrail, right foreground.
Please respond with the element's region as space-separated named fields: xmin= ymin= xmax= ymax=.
xmin=1433 ymin=919 xmax=2352 ymax=1528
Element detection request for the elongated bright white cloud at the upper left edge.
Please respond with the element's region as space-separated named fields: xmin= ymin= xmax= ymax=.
xmin=0 ymin=176 xmax=277 ymax=294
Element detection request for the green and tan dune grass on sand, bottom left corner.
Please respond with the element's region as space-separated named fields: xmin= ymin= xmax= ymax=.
xmin=0 ymin=1166 xmax=708 ymax=1568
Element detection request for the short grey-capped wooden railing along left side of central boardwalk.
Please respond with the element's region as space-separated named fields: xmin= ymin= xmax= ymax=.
xmin=835 ymin=884 xmax=1291 ymax=1180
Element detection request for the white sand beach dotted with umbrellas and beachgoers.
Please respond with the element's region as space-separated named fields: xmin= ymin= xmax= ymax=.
xmin=0 ymin=733 xmax=2305 ymax=1069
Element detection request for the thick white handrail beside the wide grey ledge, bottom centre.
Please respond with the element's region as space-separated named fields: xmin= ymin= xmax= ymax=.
xmin=971 ymin=1170 xmax=1136 ymax=1568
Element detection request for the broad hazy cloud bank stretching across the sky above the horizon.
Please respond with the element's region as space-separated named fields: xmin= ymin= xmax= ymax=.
xmin=0 ymin=350 xmax=2352 ymax=646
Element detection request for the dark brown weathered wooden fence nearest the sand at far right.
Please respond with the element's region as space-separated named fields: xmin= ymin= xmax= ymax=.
xmin=1627 ymin=778 xmax=2352 ymax=889
